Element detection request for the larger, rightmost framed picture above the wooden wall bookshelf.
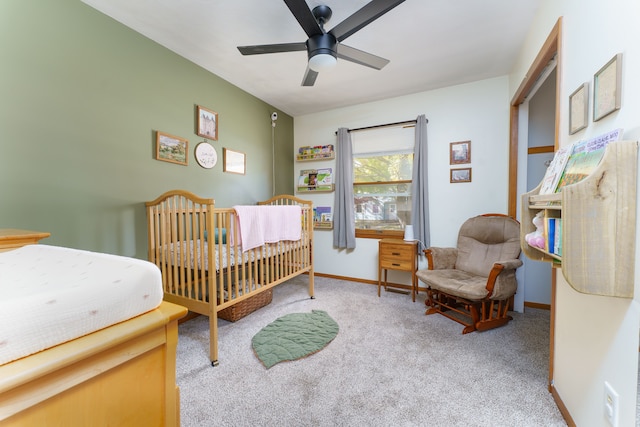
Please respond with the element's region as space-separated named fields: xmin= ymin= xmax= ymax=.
xmin=593 ymin=53 xmax=622 ymax=122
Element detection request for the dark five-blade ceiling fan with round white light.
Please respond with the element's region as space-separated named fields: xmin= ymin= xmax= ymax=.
xmin=238 ymin=0 xmax=404 ymax=86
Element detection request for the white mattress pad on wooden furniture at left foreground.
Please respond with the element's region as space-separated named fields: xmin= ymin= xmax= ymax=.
xmin=0 ymin=245 xmax=162 ymax=365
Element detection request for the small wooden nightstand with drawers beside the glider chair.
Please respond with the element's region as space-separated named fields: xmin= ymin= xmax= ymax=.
xmin=378 ymin=239 xmax=418 ymax=302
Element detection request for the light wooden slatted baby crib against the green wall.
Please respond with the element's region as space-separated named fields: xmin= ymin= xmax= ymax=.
xmin=146 ymin=190 xmax=313 ymax=366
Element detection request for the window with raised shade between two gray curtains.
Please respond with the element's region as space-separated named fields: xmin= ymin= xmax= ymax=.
xmin=351 ymin=126 xmax=415 ymax=238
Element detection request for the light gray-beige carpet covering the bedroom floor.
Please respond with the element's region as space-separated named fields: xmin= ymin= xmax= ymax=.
xmin=177 ymin=276 xmax=566 ymax=426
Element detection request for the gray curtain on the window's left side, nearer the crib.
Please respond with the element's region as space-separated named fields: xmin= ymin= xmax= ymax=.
xmin=333 ymin=128 xmax=356 ymax=249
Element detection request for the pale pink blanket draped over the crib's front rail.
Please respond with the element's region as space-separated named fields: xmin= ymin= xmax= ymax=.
xmin=231 ymin=205 xmax=302 ymax=251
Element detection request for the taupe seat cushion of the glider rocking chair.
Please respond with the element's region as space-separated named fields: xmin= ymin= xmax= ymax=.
xmin=416 ymin=270 xmax=488 ymax=300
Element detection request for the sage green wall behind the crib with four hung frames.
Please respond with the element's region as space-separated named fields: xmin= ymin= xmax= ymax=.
xmin=0 ymin=0 xmax=293 ymax=259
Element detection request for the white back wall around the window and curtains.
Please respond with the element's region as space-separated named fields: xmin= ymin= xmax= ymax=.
xmin=292 ymin=76 xmax=509 ymax=284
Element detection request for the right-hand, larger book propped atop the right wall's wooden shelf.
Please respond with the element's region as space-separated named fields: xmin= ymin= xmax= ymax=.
xmin=555 ymin=129 xmax=622 ymax=193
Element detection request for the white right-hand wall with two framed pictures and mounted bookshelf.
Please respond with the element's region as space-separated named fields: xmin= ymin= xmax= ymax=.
xmin=510 ymin=0 xmax=640 ymax=426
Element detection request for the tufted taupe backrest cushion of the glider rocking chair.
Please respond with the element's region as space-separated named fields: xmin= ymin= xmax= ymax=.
xmin=455 ymin=216 xmax=520 ymax=285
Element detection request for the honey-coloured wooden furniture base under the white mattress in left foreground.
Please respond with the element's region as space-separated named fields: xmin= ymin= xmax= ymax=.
xmin=0 ymin=302 xmax=187 ymax=426
